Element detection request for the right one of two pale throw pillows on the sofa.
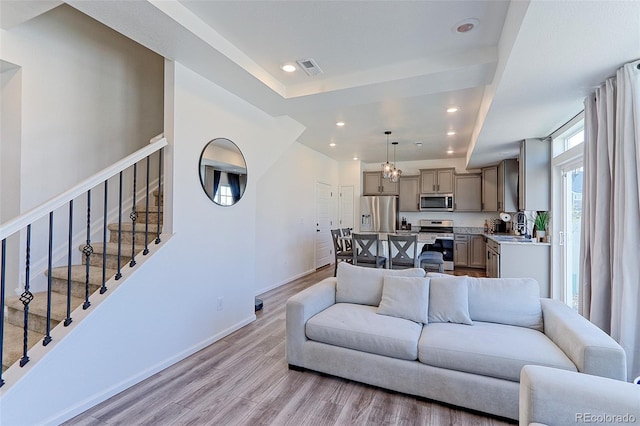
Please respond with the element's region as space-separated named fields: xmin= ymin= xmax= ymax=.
xmin=429 ymin=277 xmax=473 ymax=325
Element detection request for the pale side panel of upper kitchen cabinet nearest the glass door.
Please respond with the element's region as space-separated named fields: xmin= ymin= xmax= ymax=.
xmin=518 ymin=139 xmax=551 ymax=211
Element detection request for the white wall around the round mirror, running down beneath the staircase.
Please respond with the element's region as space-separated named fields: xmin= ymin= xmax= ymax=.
xmin=0 ymin=57 xmax=308 ymax=425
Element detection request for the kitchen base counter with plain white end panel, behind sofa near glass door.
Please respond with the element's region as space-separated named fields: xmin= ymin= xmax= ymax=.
xmin=485 ymin=234 xmax=551 ymax=297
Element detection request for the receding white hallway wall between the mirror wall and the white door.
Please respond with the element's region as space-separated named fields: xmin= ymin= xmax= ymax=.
xmin=255 ymin=142 xmax=338 ymax=294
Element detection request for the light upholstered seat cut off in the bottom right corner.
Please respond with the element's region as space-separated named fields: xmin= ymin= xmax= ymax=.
xmin=519 ymin=365 xmax=640 ymax=426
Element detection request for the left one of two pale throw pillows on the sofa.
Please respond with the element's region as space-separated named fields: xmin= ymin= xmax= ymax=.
xmin=377 ymin=276 xmax=429 ymax=324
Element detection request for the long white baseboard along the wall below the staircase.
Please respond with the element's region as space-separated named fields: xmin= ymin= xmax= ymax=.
xmin=43 ymin=315 xmax=256 ymax=425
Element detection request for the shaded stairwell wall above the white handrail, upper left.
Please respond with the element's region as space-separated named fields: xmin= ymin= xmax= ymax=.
xmin=0 ymin=5 xmax=163 ymax=215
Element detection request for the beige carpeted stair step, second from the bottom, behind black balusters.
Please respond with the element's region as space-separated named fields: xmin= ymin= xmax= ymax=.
xmin=5 ymin=292 xmax=84 ymax=334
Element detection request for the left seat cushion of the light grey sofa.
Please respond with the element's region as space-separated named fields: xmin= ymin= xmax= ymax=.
xmin=305 ymin=303 xmax=422 ymax=360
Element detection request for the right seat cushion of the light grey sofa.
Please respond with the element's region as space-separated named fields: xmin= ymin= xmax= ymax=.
xmin=418 ymin=321 xmax=577 ymax=382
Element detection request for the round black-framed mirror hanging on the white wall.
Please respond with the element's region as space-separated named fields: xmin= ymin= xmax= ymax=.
xmin=199 ymin=138 xmax=247 ymax=206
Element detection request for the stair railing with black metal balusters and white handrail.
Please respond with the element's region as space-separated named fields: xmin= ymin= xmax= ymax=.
xmin=0 ymin=138 xmax=167 ymax=387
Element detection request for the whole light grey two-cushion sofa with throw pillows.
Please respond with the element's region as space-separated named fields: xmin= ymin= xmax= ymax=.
xmin=286 ymin=262 xmax=626 ymax=420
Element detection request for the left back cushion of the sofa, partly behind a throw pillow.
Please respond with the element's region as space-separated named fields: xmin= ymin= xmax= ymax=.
xmin=336 ymin=262 xmax=425 ymax=306
